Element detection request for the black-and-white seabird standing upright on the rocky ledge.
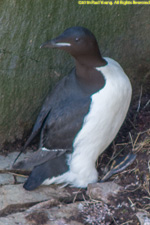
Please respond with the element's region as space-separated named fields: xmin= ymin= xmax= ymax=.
xmin=13 ymin=26 xmax=132 ymax=191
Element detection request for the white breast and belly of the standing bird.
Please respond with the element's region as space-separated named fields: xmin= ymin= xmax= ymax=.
xmin=42 ymin=58 xmax=132 ymax=187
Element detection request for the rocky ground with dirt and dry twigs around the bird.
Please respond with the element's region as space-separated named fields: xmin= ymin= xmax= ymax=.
xmin=0 ymin=92 xmax=150 ymax=225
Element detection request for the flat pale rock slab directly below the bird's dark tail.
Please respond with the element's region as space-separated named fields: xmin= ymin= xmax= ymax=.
xmin=0 ymin=184 xmax=71 ymax=216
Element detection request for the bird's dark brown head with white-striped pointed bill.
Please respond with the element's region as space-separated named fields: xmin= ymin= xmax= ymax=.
xmin=41 ymin=27 xmax=100 ymax=62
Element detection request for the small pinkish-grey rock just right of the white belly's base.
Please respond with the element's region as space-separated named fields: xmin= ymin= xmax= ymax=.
xmin=87 ymin=182 xmax=122 ymax=203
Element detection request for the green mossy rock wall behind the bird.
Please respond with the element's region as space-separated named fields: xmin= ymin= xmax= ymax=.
xmin=0 ymin=0 xmax=150 ymax=146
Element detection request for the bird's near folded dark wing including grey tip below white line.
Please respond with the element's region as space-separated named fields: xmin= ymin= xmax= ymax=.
xmin=13 ymin=94 xmax=91 ymax=170
